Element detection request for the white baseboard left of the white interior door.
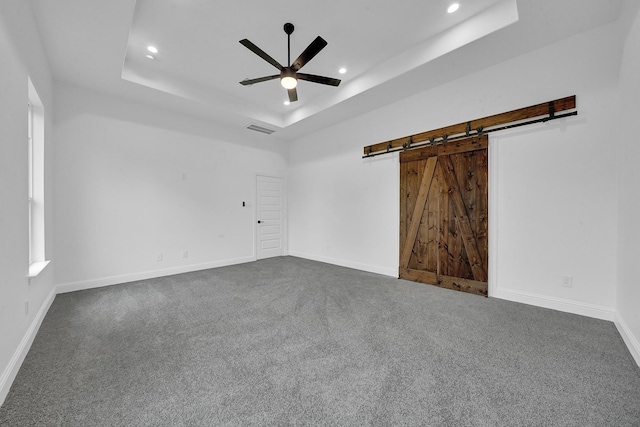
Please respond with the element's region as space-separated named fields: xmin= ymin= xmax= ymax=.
xmin=56 ymin=256 xmax=256 ymax=294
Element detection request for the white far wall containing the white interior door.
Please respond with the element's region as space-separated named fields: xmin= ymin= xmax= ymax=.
xmin=54 ymin=85 xmax=287 ymax=291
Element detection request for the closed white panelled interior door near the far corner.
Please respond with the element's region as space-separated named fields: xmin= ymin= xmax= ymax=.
xmin=256 ymin=175 xmax=284 ymax=259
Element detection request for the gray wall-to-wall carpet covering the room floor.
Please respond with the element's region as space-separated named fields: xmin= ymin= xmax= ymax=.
xmin=0 ymin=257 xmax=640 ymax=426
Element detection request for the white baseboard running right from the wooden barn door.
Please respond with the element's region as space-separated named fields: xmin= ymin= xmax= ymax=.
xmin=492 ymin=288 xmax=614 ymax=321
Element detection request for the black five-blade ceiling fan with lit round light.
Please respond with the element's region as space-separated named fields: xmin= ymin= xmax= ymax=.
xmin=240 ymin=23 xmax=340 ymax=102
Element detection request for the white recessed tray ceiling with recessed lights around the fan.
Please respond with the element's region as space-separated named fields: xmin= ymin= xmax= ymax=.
xmin=31 ymin=0 xmax=622 ymax=139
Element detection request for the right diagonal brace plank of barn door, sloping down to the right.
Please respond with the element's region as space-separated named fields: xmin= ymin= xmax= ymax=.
xmin=438 ymin=156 xmax=487 ymax=282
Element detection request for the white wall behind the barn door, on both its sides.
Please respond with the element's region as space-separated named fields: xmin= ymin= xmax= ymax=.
xmin=289 ymin=19 xmax=620 ymax=320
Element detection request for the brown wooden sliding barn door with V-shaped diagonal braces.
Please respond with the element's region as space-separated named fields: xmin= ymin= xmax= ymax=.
xmin=399 ymin=135 xmax=489 ymax=296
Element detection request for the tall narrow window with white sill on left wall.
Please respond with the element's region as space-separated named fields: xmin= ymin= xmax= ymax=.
xmin=27 ymin=79 xmax=49 ymax=277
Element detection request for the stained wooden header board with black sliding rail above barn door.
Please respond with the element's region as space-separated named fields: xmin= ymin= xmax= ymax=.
xmin=362 ymin=95 xmax=578 ymax=159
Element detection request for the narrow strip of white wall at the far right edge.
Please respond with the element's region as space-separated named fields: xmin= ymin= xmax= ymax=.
xmin=616 ymin=3 xmax=640 ymax=365
